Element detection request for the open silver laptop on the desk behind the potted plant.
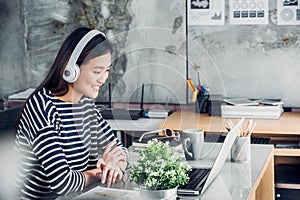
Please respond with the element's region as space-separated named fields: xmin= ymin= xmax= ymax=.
xmin=177 ymin=118 xmax=244 ymax=195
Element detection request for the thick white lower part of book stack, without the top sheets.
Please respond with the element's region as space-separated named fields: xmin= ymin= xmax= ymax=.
xmin=221 ymin=104 xmax=283 ymax=119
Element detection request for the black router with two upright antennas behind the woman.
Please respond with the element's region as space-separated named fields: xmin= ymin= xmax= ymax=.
xmin=100 ymin=84 xmax=144 ymax=120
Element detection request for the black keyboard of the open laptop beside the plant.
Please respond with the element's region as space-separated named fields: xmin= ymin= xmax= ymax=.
xmin=179 ymin=168 xmax=210 ymax=190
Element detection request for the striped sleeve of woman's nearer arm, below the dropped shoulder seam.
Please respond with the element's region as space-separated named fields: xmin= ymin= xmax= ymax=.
xmin=32 ymin=126 xmax=85 ymax=195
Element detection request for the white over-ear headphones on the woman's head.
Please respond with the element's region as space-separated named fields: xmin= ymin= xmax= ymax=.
xmin=63 ymin=30 xmax=106 ymax=83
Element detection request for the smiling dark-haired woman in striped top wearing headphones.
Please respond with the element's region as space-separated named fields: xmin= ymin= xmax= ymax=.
xmin=16 ymin=27 xmax=128 ymax=199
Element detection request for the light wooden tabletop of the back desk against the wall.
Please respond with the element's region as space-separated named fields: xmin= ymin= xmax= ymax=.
xmin=159 ymin=111 xmax=300 ymax=136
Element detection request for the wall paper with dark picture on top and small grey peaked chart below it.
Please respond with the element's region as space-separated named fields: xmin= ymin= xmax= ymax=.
xmin=187 ymin=0 xmax=225 ymax=25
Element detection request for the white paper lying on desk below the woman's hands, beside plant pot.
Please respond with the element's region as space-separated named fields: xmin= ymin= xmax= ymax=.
xmin=74 ymin=186 xmax=140 ymax=200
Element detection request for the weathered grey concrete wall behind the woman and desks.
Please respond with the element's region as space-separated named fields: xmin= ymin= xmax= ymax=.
xmin=0 ymin=0 xmax=300 ymax=107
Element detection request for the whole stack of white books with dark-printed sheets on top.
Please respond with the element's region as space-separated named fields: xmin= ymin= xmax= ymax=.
xmin=221 ymin=98 xmax=283 ymax=119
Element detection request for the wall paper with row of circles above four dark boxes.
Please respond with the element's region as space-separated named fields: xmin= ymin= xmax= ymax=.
xmin=229 ymin=0 xmax=269 ymax=24
